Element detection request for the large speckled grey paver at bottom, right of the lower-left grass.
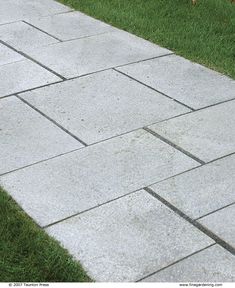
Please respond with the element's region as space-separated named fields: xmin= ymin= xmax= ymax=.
xmin=47 ymin=190 xmax=213 ymax=282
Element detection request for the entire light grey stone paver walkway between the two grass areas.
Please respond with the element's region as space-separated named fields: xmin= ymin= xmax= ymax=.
xmin=0 ymin=0 xmax=235 ymax=282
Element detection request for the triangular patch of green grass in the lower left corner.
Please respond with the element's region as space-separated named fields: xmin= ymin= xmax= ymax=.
xmin=0 ymin=188 xmax=90 ymax=282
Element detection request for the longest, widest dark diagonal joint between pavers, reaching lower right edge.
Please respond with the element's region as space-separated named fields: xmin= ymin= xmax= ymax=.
xmin=144 ymin=187 xmax=235 ymax=255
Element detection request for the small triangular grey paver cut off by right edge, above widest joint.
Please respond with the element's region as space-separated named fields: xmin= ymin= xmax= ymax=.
xmin=199 ymin=204 xmax=235 ymax=248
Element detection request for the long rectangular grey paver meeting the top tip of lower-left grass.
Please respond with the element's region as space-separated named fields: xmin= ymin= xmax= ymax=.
xmin=0 ymin=129 xmax=198 ymax=226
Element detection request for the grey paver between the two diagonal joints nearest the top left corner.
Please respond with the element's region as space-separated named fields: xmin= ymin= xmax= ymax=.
xmin=0 ymin=22 xmax=59 ymax=50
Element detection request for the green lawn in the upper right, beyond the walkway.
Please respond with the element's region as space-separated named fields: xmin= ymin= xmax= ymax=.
xmin=60 ymin=0 xmax=235 ymax=78
